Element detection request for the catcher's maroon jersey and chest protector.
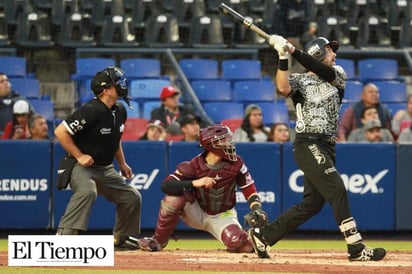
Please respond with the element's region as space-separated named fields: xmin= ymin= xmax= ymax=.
xmin=165 ymin=153 xmax=256 ymax=215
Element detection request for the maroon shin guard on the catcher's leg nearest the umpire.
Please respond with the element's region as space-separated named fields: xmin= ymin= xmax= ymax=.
xmin=154 ymin=195 xmax=186 ymax=248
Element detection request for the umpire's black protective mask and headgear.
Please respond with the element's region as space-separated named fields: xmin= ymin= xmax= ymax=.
xmin=90 ymin=67 xmax=130 ymax=107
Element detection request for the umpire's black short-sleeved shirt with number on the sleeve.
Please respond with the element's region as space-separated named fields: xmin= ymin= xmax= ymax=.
xmin=63 ymin=98 xmax=127 ymax=166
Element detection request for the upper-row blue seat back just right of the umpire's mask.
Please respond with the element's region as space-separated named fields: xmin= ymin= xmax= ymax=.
xmin=120 ymin=58 xmax=161 ymax=81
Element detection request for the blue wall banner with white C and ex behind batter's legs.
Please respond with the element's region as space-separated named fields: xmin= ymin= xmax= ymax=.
xmin=282 ymin=143 xmax=395 ymax=230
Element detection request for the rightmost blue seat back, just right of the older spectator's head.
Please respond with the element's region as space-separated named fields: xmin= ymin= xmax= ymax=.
xmin=373 ymin=81 xmax=408 ymax=103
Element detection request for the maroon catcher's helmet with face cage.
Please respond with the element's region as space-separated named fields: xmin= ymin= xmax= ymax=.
xmin=199 ymin=124 xmax=237 ymax=162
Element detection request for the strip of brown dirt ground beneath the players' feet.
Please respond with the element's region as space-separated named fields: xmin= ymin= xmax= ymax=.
xmin=0 ymin=249 xmax=412 ymax=274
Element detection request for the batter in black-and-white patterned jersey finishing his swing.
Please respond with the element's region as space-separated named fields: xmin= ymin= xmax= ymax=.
xmin=249 ymin=35 xmax=386 ymax=261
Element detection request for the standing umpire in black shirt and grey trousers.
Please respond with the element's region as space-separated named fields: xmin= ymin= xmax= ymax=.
xmin=55 ymin=67 xmax=141 ymax=250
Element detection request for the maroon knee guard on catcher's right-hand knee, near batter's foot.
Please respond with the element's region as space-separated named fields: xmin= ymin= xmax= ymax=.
xmin=221 ymin=224 xmax=253 ymax=253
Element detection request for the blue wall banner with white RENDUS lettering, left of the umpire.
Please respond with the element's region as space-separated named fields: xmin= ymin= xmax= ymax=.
xmin=0 ymin=140 xmax=51 ymax=229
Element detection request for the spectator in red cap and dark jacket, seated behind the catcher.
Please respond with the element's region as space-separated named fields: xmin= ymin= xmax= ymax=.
xmin=151 ymin=86 xmax=205 ymax=135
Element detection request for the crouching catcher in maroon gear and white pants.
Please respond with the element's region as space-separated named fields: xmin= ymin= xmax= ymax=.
xmin=138 ymin=125 xmax=268 ymax=253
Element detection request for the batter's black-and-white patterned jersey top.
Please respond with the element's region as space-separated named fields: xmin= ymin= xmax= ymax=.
xmin=289 ymin=66 xmax=346 ymax=135
